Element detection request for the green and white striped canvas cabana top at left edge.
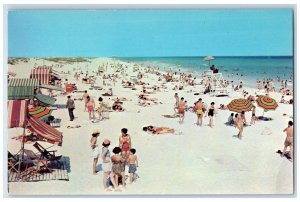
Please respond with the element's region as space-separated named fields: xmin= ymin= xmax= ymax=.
xmin=7 ymin=78 xmax=39 ymax=100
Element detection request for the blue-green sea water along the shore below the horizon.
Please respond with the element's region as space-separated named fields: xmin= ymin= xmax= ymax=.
xmin=118 ymin=56 xmax=294 ymax=87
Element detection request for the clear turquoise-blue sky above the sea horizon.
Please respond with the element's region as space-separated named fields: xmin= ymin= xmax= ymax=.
xmin=8 ymin=9 xmax=293 ymax=57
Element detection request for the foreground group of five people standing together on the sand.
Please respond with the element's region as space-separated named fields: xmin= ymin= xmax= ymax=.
xmin=90 ymin=128 xmax=138 ymax=191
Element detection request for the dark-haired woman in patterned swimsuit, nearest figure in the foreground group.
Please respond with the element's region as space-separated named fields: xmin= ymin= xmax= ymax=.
xmin=111 ymin=147 xmax=126 ymax=191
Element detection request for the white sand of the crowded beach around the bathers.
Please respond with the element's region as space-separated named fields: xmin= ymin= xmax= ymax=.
xmin=8 ymin=58 xmax=294 ymax=195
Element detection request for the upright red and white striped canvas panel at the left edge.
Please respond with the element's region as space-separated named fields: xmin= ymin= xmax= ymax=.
xmin=7 ymin=100 xmax=28 ymax=128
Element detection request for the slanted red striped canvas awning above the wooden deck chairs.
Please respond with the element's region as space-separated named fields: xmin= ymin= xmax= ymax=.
xmin=28 ymin=117 xmax=63 ymax=146
